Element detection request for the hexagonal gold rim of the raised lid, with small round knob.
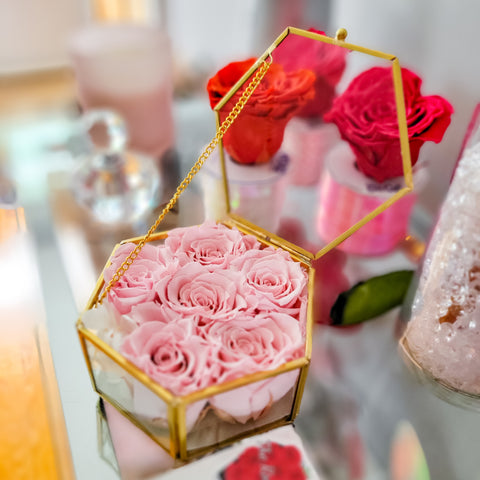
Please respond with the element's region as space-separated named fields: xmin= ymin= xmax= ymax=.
xmin=214 ymin=27 xmax=413 ymax=260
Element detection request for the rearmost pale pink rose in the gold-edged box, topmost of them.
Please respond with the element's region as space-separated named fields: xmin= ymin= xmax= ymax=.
xmin=165 ymin=221 xmax=260 ymax=267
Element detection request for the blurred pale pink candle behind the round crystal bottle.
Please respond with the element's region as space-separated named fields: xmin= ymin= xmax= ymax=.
xmin=71 ymin=25 xmax=174 ymax=158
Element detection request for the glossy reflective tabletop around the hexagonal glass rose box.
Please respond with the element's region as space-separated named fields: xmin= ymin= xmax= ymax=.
xmin=2 ymin=91 xmax=480 ymax=480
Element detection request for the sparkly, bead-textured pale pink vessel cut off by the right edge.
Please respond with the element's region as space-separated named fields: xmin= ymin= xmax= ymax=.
xmin=406 ymin=142 xmax=480 ymax=394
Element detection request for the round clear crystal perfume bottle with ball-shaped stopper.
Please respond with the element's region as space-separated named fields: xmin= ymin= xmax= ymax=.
xmin=72 ymin=110 xmax=161 ymax=224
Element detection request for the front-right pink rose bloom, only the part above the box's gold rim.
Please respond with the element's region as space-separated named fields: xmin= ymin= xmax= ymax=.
xmin=205 ymin=312 xmax=304 ymax=382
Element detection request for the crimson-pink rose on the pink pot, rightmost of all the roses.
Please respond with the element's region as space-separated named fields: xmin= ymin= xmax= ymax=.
xmin=324 ymin=67 xmax=453 ymax=182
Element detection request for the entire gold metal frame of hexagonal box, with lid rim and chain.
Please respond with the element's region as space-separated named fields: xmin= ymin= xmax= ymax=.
xmin=77 ymin=27 xmax=413 ymax=460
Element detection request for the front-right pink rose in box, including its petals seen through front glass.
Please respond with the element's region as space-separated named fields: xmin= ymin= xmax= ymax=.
xmin=207 ymin=312 xmax=304 ymax=423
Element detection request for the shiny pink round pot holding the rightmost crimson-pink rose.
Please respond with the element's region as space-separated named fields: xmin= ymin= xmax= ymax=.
xmin=316 ymin=142 xmax=426 ymax=255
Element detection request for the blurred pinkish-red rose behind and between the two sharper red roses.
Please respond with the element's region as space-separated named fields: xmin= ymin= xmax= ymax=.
xmin=272 ymin=28 xmax=348 ymax=118
